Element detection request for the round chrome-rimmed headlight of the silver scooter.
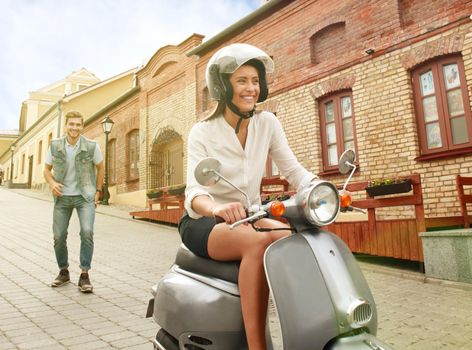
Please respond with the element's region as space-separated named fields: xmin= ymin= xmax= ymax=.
xmin=301 ymin=181 xmax=339 ymax=226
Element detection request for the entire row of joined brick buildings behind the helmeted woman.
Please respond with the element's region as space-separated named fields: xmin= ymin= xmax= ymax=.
xmin=83 ymin=0 xmax=472 ymax=230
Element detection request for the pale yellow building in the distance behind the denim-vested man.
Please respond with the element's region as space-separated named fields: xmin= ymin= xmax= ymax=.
xmin=0 ymin=68 xmax=134 ymax=189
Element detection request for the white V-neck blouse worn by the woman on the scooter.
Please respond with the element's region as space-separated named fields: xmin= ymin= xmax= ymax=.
xmin=185 ymin=112 xmax=316 ymax=219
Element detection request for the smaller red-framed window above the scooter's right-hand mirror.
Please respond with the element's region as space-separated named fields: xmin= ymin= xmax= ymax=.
xmin=319 ymin=91 xmax=357 ymax=171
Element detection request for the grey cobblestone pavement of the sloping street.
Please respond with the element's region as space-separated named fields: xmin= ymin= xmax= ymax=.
xmin=0 ymin=187 xmax=472 ymax=350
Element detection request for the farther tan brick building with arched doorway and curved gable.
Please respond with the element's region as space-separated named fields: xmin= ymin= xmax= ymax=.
xmin=85 ymin=34 xmax=203 ymax=206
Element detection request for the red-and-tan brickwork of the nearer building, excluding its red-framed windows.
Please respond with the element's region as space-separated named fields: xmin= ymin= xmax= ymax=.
xmin=191 ymin=0 xmax=472 ymax=217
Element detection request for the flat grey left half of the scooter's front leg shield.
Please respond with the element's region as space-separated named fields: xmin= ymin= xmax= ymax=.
xmin=264 ymin=234 xmax=338 ymax=350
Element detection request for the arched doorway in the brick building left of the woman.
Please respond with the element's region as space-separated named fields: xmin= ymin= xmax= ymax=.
xmin=148 ymin=127 xmax=184 ymax=188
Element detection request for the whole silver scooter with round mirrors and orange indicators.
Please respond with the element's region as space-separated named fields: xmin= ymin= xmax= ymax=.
xmin=146 ymin=150 xmax=392 ymax=350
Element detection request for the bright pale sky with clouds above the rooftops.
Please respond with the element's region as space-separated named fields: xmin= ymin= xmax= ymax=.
xmin=0 ymin=0 xmax=261 ymax=130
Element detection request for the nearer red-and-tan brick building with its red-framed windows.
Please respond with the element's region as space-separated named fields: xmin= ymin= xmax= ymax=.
xmin=190 ymin=0 xmax=472 ymax=224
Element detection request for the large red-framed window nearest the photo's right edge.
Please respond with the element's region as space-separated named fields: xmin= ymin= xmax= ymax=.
xmin=412 ymin=55 xmax=472 ymax=159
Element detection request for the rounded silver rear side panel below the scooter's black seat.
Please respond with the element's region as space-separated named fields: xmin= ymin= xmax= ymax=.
xmin=153 ymin=270 xmax=246 ymax=349
